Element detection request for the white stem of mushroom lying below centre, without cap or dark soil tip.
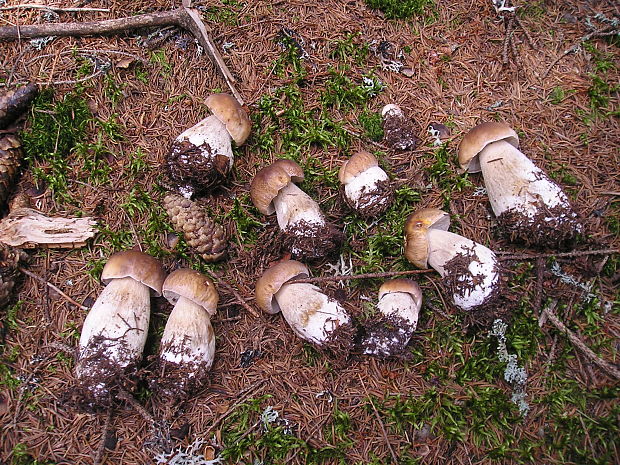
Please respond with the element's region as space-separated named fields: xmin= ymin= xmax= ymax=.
xmin=275 ymin=283 xmax=351 ymax=345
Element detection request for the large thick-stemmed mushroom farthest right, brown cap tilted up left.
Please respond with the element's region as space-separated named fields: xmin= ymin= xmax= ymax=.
xmin=458 ymin=122 xmax=582 ymax=245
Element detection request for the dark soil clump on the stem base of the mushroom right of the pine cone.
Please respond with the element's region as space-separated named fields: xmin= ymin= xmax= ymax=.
xmin=280 ymin=220 xmax=344 ymax=260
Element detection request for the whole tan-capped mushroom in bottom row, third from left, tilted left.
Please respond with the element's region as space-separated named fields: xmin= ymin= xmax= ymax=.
xmin=255 ymin=260 xmax=353 ymax=353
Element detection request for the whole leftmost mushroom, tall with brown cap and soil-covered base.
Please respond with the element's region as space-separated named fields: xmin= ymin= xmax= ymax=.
xmin=75 ymin=250 xmax=165 ymax=405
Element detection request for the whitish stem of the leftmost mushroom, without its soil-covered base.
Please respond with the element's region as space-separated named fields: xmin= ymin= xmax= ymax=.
xmin=76 ymin=278 xmax=151 ymax=370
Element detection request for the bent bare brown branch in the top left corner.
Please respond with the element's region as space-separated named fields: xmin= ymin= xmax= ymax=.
xmin=0 ymin=7 xmax=244 ymax=105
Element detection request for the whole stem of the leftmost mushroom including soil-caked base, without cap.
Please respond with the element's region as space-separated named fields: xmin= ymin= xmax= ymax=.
xmin=76 ymin=278 xmax=150 ymax=400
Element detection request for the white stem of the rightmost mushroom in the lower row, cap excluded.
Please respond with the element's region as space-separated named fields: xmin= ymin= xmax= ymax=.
xmin=427 ymin=229 xmax=500 ymax=310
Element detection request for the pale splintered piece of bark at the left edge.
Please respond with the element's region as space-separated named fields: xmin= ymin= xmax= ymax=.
xmin=0 ymin=207 xmax=96 ymax=249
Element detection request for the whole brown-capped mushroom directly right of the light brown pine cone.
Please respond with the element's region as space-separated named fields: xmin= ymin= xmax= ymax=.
xmin=250 ymin=160 xmax=344 ymax=259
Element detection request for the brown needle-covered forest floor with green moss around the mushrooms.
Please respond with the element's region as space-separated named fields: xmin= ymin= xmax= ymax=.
xmin=0 ymin=0 xmax=620 ymax=465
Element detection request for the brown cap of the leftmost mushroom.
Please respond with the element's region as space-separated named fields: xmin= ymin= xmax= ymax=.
xmin=101 ymin=250 xmax=166 ymax=297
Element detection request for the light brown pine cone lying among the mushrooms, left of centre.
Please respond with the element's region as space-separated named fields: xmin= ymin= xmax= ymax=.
xmin=164 ymin=194 xmax=226 ymax=262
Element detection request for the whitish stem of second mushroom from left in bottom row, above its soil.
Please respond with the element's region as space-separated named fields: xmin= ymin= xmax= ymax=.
xmin=160 ymin=297 xmax=215 ymax=368
